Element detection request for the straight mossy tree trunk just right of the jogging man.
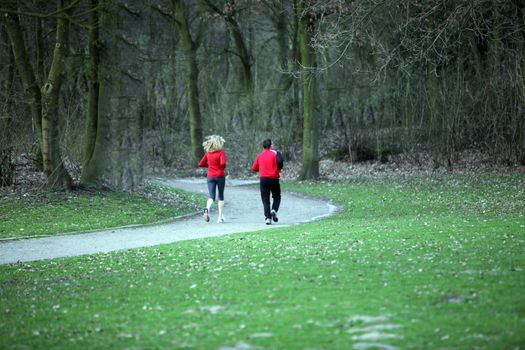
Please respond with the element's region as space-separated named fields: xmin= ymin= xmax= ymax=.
xmin=297 ymin=0 xmax=319 ymax=180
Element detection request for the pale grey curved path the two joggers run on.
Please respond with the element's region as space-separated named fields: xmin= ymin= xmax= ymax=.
xmin=0 ymin=178 xmax=337 ymax=264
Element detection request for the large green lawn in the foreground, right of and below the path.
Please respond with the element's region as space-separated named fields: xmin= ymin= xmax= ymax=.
xmin=0 ymin=174 xmax=525 ymax=350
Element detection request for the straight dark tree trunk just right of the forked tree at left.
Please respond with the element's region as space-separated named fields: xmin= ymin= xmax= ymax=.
xmin=80 ymin=0 xmax=102 ymax=186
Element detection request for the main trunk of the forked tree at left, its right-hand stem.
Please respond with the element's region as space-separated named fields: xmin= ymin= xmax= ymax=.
xmin=41 ymin=0 xmax=73 ymax=188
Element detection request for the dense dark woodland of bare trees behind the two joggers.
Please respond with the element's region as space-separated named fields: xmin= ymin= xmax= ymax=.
xmin=0 ymin=0 xmax=525 ymax=190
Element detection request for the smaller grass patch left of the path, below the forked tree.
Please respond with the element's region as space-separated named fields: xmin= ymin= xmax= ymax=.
xmin=0 ymin=185 xmax=202 ymax=238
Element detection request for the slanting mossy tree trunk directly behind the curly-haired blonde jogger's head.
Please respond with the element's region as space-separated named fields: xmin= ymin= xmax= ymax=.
xmin=173 ymin=0 xmax=204 ymax=166
